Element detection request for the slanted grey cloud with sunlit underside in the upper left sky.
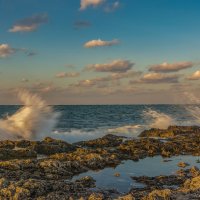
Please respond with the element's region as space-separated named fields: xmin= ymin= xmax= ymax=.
xmin=8 ymin=14 xmax=48 ymax=33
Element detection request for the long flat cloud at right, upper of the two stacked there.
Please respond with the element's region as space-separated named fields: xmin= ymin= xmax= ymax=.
xmin=149 ymin=62 xmax=194 ymax=73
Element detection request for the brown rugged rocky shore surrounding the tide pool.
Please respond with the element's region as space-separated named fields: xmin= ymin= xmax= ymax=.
xmin=0 ymin=126 xmax=200 ymax=200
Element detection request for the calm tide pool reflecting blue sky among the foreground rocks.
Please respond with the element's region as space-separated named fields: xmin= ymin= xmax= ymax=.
xmin=73 ymin=156 xmax=200 ymax=193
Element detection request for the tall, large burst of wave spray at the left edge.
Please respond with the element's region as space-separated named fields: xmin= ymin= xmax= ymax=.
xmin=0 ymin=90 xmax=60 ymax=140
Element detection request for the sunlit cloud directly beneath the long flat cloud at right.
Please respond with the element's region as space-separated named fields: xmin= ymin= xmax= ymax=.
xmin=134 ymin=73 xmax=179 ymax=83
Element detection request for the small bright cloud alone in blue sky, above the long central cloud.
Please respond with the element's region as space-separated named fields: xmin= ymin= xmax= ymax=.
xmin=84 ymin=39 xmax=119 ymax=48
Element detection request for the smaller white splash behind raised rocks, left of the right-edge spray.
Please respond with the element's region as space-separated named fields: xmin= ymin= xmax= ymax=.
xmin=143 ymin=109 xmax=174 ymax=129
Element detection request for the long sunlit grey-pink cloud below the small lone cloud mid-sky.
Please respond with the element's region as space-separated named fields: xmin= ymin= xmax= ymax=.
xmin=86 ymin=60 xmax=134 ymax=73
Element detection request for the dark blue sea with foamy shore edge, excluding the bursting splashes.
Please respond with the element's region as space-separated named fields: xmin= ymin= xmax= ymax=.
xmin=0 ymin=105 xmax=198 ymax=142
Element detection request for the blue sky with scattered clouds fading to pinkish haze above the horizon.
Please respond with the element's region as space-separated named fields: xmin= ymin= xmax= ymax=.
xmin=0 ymin=0 xmax=200 ymax=105
